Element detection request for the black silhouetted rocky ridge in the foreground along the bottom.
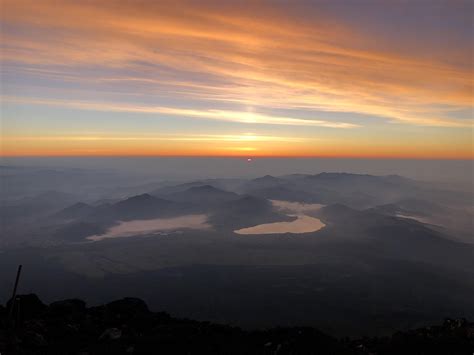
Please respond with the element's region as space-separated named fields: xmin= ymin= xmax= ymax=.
xmin=0 ymin=294 xmax=474 ymax=355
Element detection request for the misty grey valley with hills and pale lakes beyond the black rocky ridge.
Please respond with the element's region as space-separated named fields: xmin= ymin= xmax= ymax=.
xmin=0 ymin=161 xmax=474 ymax=335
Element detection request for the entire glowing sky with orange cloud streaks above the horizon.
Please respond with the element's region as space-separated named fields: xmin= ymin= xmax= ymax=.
xmin=0 ymin=0 xmax=474 ymax=159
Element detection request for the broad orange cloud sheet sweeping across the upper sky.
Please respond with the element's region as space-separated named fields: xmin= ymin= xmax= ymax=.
xmin=2 ymin=0 xmax=473 ymax=127
